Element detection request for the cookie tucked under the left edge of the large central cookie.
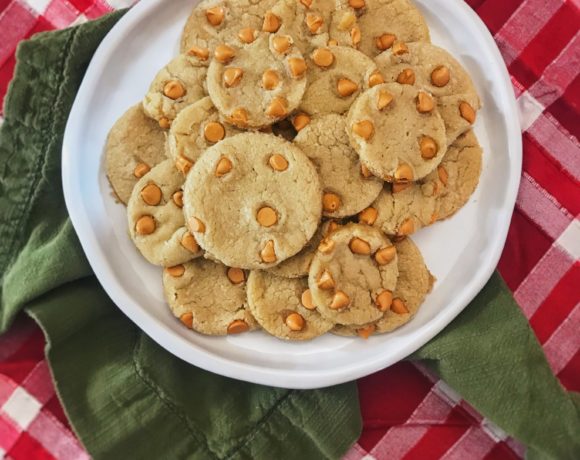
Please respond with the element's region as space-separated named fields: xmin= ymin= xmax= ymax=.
xmin=127 ymin=160 xmax=202 ymax=267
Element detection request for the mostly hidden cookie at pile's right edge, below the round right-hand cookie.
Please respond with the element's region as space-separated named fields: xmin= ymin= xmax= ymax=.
xmin=427 ymin=131 xmax=483 ymax=220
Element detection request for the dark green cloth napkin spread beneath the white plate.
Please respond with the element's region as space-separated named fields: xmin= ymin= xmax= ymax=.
xmin=0 ymin=12 xmax=580 ymax=459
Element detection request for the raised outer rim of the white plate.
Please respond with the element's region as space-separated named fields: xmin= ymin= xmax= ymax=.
xmin=61 ymin=0 xmax=522 ymax=389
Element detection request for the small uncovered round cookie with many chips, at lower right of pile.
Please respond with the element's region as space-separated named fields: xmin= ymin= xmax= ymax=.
xmin=308 ymin=224 xmax=399 ymax=325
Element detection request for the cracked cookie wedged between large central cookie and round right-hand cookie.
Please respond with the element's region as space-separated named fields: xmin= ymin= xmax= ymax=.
xmin=294 ymin=114 xmax=383 ymax=217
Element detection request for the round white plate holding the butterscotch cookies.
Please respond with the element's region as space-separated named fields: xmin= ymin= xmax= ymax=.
xmin=62 ymin=0 xmax=521 ymax=388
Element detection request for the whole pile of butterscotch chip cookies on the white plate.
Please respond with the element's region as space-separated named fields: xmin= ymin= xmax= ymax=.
xmin=106 ymin=0 xmax=482 ymax=340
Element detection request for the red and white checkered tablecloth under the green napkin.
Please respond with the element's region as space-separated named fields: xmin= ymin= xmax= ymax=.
xmin=0 ymin=0 xmax=580 ymax=460
